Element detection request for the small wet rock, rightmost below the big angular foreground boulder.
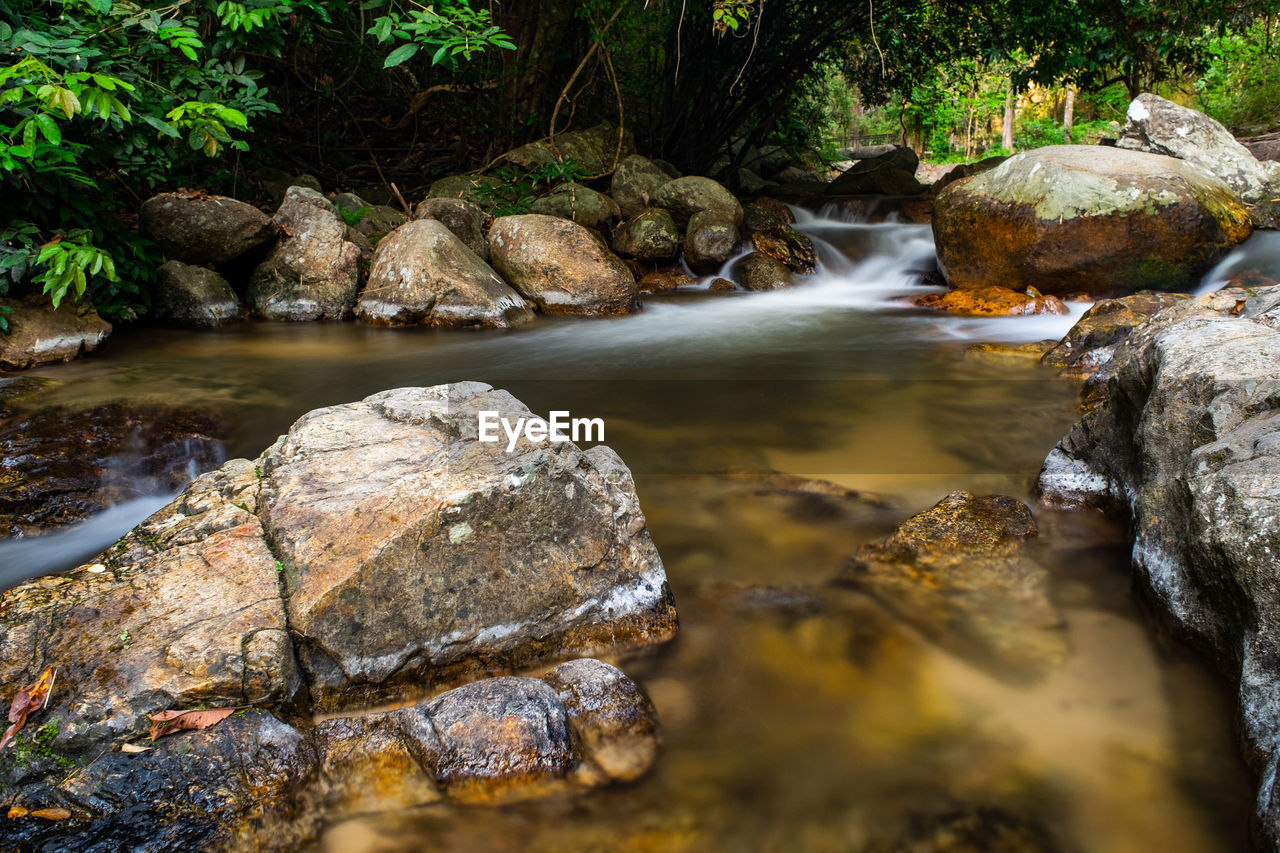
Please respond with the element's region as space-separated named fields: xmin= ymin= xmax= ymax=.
xmin=543 ymin=658 xmax=658 ymax=781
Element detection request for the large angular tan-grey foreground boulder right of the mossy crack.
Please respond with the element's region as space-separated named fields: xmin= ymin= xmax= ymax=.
xmin=261 ymin=381 xmax=676 ymax=710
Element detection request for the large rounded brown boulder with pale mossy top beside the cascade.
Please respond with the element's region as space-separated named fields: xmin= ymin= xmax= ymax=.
xmin=933 ymin=145 xmax=1251 ymax=297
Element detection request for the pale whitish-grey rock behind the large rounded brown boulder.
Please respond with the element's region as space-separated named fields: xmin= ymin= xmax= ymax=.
xmin=1116 ymin=93 xmax=1280 ymax=228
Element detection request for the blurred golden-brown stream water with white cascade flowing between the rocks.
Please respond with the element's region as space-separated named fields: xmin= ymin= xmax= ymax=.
xmin=0 ymin=214 xmax=1264 ymax=853
